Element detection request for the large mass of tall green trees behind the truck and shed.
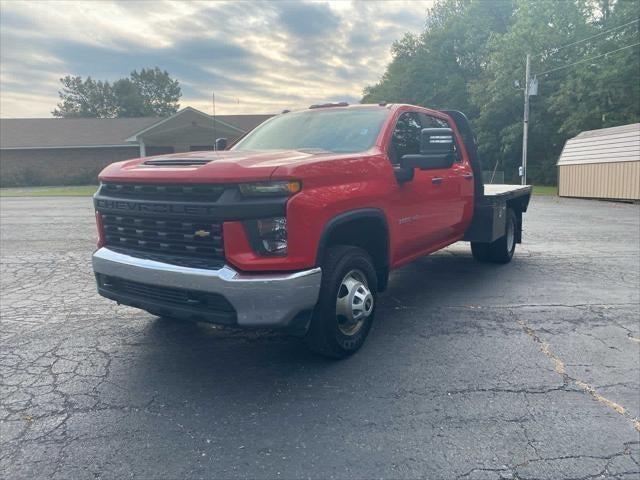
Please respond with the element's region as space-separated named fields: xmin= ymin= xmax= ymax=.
xmin=362 ymin=0 xmax=640 ymax=185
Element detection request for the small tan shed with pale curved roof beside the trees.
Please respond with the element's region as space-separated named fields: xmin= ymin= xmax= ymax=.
xmin=557 ymin=123 xmax=640 ymax=200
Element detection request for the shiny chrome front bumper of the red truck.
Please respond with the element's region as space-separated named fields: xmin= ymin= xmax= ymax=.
xmin=93 ymin=247 xmax=322 ymax=327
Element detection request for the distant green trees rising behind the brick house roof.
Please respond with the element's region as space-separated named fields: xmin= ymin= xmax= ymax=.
xmin=52 ymin=67 xmax=182 ymax=118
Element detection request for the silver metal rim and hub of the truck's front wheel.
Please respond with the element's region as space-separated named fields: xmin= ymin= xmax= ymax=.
xmin=336 ymin=270 xmax=374 ymax=335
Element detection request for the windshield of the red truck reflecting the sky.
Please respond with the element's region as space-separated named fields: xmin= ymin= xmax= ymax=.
xmin=233 ymin=107 xmax=389 ymax=153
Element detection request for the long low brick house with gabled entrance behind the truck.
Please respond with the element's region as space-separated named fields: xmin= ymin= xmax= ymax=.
xmin=0 ymin=107 xmax=271 ymax=187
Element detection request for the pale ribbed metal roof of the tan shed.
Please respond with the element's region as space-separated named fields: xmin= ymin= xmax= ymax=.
xmin=558 ymin=123 xmax=640 ymax=165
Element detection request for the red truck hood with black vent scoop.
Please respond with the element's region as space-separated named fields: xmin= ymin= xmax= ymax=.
xmin=100 ymin=150 xmax=339 ymax=183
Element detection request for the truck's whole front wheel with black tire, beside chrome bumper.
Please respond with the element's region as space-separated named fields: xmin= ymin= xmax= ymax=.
xmin=305 ymin=245 xmax=378 ymax=359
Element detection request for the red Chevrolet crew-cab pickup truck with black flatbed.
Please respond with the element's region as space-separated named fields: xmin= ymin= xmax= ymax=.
xmin=93 ymin=103 xmax=531 ymax=358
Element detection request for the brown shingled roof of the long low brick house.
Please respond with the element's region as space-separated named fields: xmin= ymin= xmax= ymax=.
xmin=0 ymin=107 xmax=271 ymax=149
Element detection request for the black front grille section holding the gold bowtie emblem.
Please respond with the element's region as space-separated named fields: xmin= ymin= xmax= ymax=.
xmin=100 ymin=213 xmax=224 ymax=267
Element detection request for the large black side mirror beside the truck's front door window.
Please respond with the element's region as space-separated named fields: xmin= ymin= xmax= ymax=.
xmin=400 ymin=128 xmax=455 ymax=170
